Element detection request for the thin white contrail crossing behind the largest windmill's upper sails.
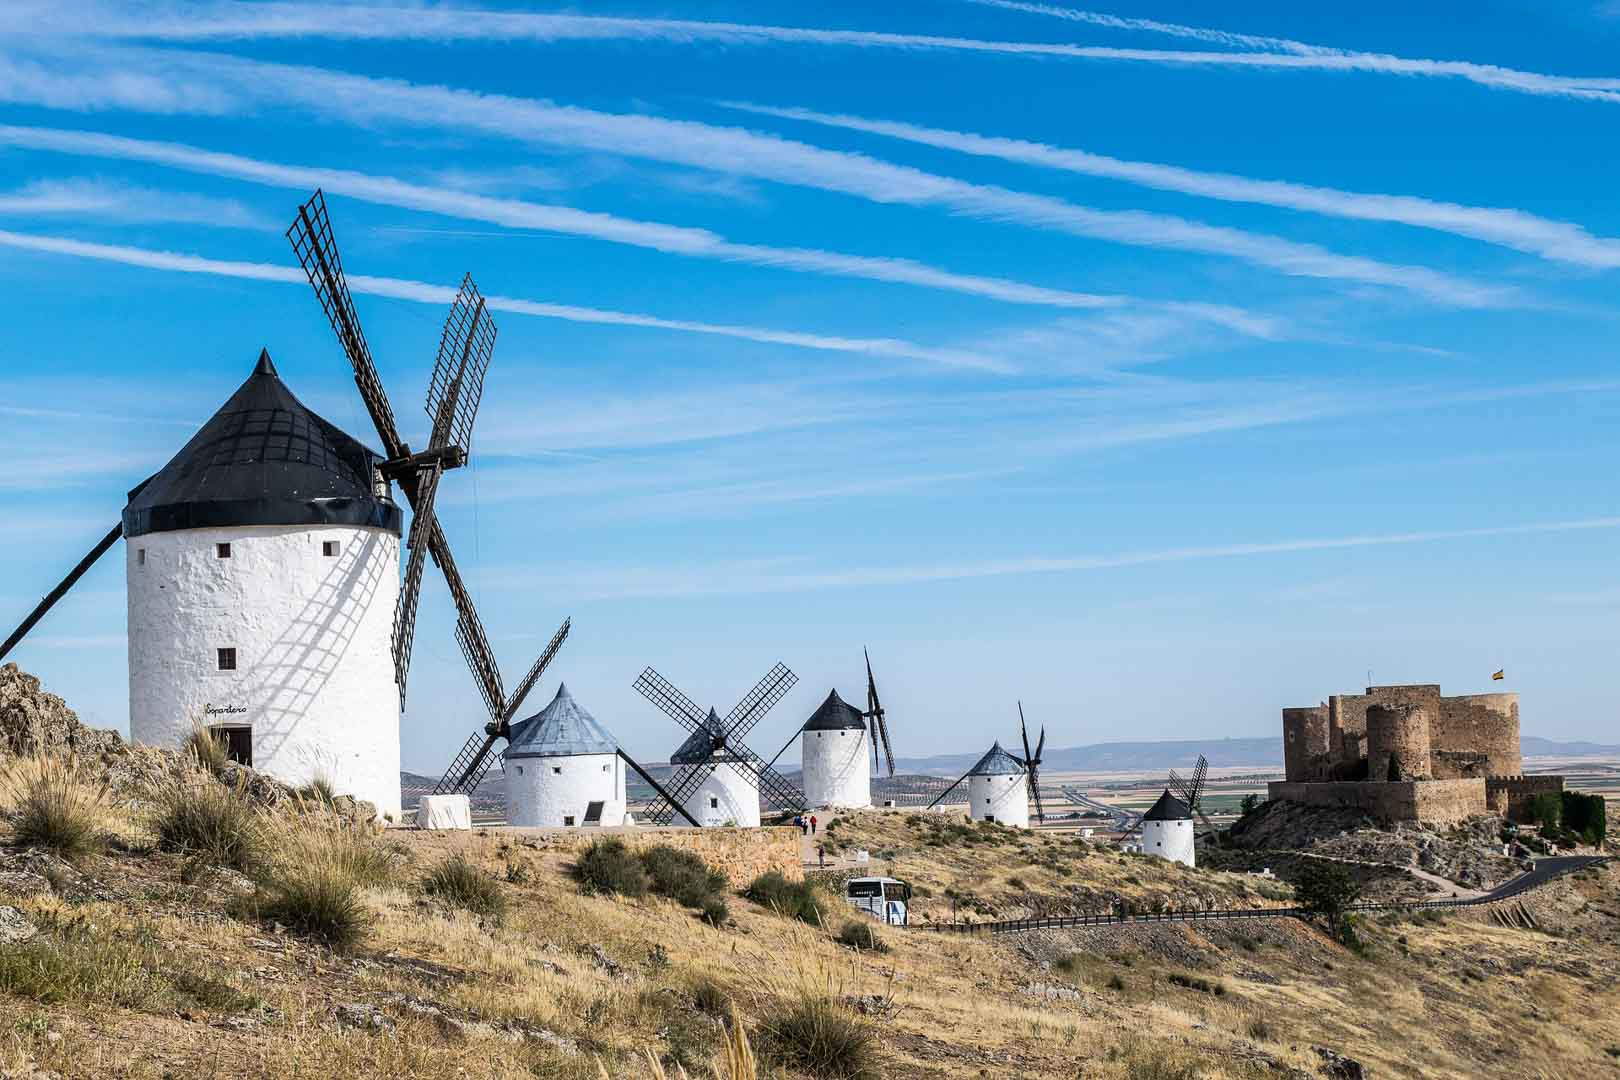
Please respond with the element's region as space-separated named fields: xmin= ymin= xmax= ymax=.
xmin=0 ymin=232 xmax=1006 ymax=371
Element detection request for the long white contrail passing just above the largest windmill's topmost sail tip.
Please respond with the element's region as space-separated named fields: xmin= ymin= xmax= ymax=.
xmin=0 ymin=126 xmax=1128 ymax=308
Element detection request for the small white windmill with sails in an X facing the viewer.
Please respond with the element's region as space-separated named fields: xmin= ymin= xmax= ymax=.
xmin=635 ymin=664 xmax=805 ymax=824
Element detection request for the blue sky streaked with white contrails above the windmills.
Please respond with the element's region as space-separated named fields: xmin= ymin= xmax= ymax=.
xmin=0 ymin=0 xmax=1620 ymax=772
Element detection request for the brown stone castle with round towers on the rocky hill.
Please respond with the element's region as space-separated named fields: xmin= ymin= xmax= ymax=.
xmin=1268 ymin=683 xmax=1563 ymax=823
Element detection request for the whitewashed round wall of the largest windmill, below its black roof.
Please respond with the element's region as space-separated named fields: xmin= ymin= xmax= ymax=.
xmin=125 ymin=525 xmax=400 ymax=819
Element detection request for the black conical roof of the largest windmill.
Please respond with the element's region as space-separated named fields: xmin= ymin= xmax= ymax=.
xmin=123 ymin=351 xmax=402 ymax=536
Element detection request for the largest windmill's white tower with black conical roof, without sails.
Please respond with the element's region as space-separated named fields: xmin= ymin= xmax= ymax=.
xmin=123 ymin=353 xmax=402 ymax=819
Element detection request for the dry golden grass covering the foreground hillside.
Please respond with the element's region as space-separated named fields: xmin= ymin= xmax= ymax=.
xmin=0 ymin=793 xmax=1620 ymax=1080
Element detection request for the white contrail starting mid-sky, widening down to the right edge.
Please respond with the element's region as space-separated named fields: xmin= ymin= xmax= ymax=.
xmin=721 ymin=102 xmax=1620 ymax=269
